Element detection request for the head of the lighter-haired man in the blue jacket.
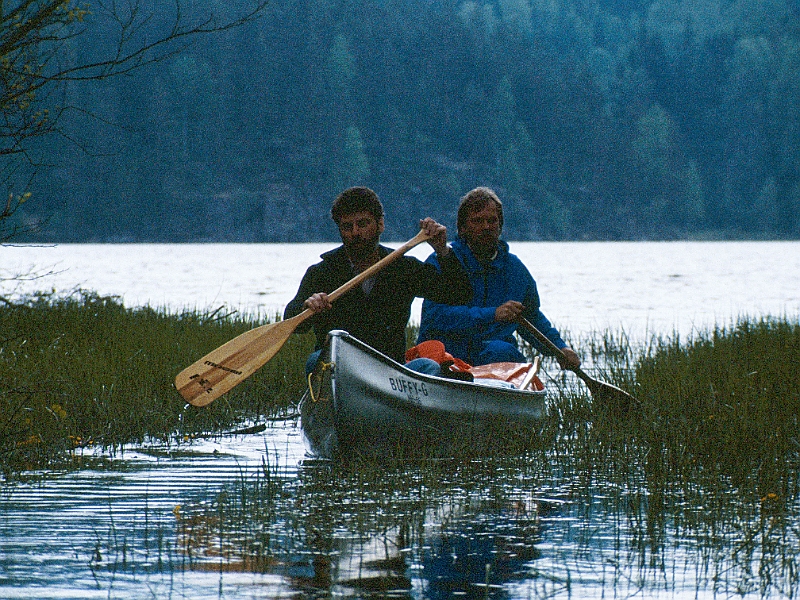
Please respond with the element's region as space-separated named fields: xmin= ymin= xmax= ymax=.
xmin=457 ymin=187 xmax=503 ymax=259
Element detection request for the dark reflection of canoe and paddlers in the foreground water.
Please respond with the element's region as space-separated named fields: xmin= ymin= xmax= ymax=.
xmin=268 ymin=463 xmax=555 ymax=598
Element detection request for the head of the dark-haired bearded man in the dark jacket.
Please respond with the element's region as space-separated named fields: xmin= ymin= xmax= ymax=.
xmin=331 ymin=187 xmax=383 ymax=261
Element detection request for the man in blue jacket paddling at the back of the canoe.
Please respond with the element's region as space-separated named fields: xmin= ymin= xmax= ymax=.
xmin=417 ymin=187 xmax=581 ymax=368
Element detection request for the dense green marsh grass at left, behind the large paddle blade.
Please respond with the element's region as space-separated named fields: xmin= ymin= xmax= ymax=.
xmin=0 ymin=291 xmax=311 ymax=472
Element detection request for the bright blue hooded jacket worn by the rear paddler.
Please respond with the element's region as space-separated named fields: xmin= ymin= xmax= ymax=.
xmin=417 ymin=238 xmax=567 ymax=364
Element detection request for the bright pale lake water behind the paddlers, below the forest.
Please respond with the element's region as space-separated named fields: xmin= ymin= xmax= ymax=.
xmin=6 ymin=242 xmax=800 ymax=337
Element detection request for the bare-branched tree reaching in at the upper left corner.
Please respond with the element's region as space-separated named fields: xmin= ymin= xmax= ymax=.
xmin=0 ymin=0 xmax=267 ymax=241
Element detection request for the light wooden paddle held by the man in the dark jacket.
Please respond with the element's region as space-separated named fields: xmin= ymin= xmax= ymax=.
xmin=175 ymin=230 xmax=429 ymax=406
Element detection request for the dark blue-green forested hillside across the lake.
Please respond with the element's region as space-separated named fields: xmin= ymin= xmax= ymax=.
xmin=6 ymin=0 xmax=800 ymax=242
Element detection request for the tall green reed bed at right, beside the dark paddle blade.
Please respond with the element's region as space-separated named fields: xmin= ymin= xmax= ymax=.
xmin=520 ymin=317 xmax=800 ymax=541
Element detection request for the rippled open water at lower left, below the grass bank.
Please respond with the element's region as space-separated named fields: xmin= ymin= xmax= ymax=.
xmin=0 ymin=426 xmax=303 ymax=599
